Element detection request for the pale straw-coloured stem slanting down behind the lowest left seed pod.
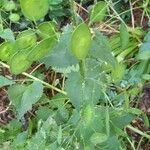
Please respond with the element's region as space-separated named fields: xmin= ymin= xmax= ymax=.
xmin=0 ymin=61 xmax=67 ymax=95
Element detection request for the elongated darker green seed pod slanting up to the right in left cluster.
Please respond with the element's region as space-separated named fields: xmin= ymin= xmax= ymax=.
xmin=28 ymin=38 xmax=56 ymax=61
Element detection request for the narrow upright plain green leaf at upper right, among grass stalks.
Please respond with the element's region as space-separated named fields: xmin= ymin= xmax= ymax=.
xmin=120 ymin=23 xmax=130 ymax=49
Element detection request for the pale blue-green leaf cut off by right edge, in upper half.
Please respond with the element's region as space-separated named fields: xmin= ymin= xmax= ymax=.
xmin=137 ymin=42 xmax=150 ymax=60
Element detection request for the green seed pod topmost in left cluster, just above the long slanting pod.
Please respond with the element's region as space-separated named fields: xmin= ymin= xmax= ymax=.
xmin=37 ymin=22 xmax=57 ymax=39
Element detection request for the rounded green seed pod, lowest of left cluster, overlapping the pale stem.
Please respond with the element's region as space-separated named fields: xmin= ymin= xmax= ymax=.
xmin=10 ymin=51 xmax=32 ymax=75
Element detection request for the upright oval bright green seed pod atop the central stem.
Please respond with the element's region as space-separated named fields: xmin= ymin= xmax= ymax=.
xmin=71 ymin=23 xmax=92 ymax=60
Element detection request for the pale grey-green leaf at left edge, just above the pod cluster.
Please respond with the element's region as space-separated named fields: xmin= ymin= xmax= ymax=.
xmin=0 ymin=28 xmax=15 ymax=41
